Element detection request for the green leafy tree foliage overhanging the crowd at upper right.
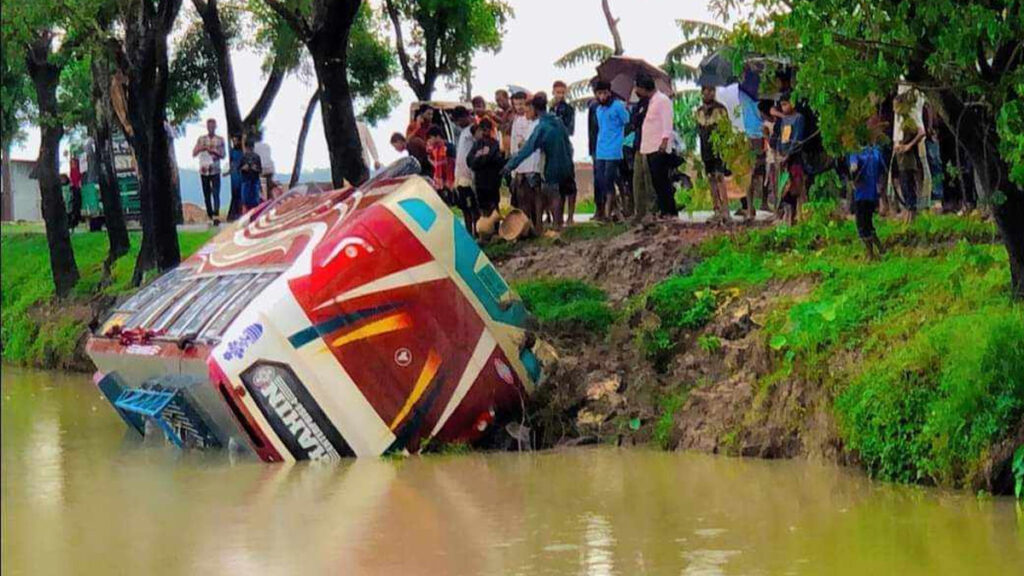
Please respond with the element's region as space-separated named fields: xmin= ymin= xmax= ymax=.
xmin=741 ymin=0 xmax=1024 ymax=199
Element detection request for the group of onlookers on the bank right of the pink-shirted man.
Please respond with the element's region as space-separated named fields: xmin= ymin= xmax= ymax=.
xmin=694 ymin=71 xmax=976 ymax=258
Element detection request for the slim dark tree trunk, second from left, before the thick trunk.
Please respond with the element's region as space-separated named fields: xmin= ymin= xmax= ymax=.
xmin=92 ymin=55 xmax=131 ymax=263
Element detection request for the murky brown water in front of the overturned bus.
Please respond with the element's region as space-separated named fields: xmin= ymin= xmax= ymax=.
xmin=0 ymin=367 xmax=1024 ymax=575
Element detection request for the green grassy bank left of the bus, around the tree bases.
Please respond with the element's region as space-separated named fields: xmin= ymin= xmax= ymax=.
xmin=0 ymin=224 xmax=213 ymax=368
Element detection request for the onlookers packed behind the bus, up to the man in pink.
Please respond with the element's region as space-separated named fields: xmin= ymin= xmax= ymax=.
xmin=391 ymin=76 xmax=682 ymax=235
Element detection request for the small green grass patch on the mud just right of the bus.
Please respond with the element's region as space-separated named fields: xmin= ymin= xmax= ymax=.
xmin=515 ymin=279 xmax=615 ymax=334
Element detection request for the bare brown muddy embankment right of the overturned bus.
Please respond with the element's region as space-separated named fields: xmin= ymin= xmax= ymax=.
xmin=496 ymin=222 xmax=843 ymax=460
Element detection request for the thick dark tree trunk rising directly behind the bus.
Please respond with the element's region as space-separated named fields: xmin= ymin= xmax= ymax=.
xmin=307 ymin=20 xmax=370 ymax=188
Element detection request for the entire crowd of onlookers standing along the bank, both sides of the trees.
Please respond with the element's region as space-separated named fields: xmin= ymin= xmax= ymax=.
xmin=186 ymin=66 xmax=967 ymax=257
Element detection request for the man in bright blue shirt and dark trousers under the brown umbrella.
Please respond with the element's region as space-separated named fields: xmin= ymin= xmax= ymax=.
xmin=594 ymin=80 xmax=630 ymax=220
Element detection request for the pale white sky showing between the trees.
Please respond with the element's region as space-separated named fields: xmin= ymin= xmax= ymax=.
xmin=12 ymin=0 xmax=712 ymax=173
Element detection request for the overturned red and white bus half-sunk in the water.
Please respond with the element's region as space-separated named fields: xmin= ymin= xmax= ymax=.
xmin=87 ymin=161 xmax=541 ymax=461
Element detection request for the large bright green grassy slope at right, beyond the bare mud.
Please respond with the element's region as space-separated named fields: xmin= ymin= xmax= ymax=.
xmin=659 ymin=203 xmax=1024 ymax=486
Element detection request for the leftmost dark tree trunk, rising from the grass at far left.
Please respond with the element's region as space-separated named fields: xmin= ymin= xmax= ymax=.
xmin=26 ymin=35 xmax=79 ymax=298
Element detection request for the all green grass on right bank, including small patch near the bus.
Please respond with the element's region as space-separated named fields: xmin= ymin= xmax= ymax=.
xmin=521 ymin=204 xmax=1024 ymax=486
